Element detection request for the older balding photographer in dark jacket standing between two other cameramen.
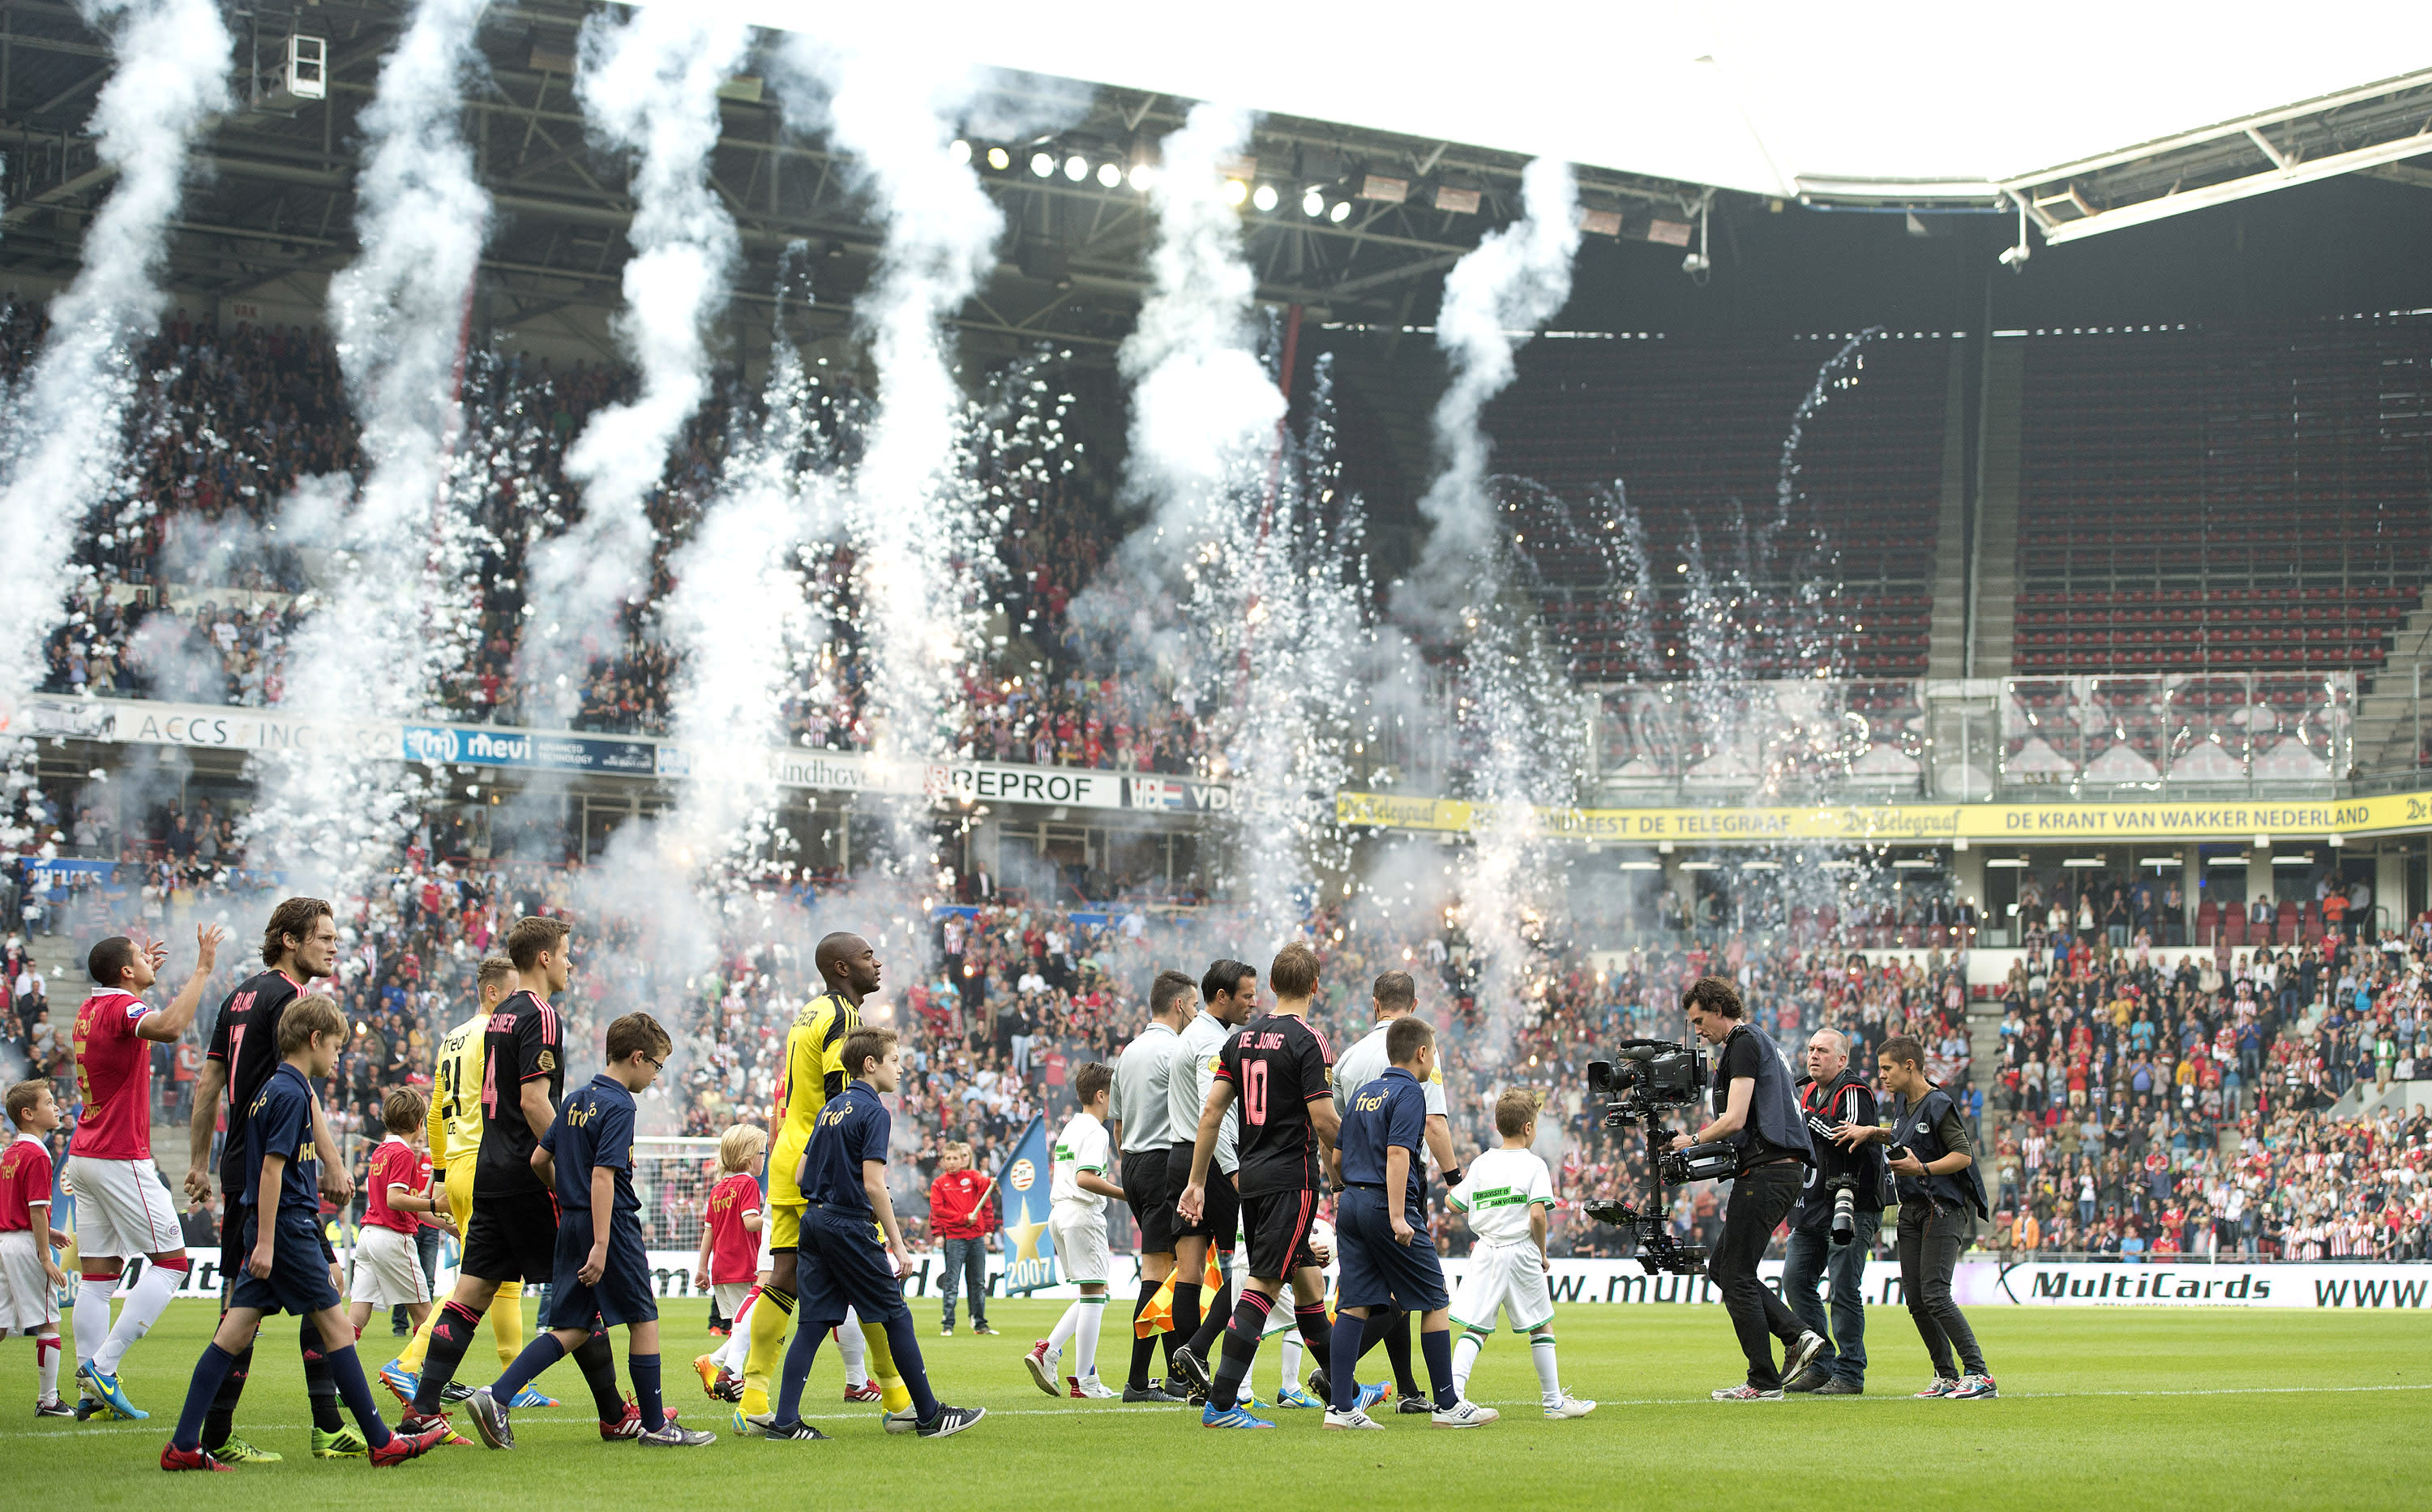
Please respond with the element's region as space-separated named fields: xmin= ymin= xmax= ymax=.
xmin=1783 ymin=1028 xmax=1899 ymax=1395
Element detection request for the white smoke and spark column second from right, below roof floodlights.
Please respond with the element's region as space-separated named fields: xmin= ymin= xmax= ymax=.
xmin=1104 ymin=105 xmax=1374 ymax=957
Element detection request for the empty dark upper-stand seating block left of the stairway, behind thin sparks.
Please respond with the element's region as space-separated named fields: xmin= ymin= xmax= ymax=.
xmin=1486 ymin=336 xmax=1948 ymax=681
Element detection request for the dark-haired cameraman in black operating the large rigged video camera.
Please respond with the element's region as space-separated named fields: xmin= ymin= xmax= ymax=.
xmin=1673 ymin=977 xmax=1824 ymax=1403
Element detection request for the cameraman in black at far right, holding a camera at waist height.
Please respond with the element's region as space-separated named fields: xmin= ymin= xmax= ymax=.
xmin=1831 ymin=1033 xmax=2002 ymax=1398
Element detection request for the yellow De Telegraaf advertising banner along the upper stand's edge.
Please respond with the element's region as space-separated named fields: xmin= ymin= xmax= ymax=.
xmin=1335 ymin=792 xmax=2432 ymax=843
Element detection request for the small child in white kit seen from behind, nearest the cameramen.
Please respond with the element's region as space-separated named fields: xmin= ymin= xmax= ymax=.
xmin=1452 ymin=1086 xmax=1595 ymax=1417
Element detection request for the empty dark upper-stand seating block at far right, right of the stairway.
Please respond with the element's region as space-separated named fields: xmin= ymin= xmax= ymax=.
xmin=2014 ymin=316 xmax=2432 ymax=674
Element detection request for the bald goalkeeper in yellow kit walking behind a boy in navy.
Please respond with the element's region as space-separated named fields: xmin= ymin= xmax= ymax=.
xmin=734 ymin=933 xmax=917 ymax=1437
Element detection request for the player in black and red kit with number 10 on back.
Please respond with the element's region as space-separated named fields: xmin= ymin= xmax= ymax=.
xmin=1175 ymin=940 xmax=1340 ymax=1427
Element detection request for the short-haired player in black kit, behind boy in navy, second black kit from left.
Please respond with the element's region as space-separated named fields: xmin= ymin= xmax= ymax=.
xmin=401 ymin=916 xmax=642 ymax=1439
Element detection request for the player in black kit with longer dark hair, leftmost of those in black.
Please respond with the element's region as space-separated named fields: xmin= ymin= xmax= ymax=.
xmin=171 ymin=897 xmax=350 ymax=1463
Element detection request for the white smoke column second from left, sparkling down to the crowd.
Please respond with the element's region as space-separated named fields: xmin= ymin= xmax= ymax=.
xmin=253 ymin=0 xmax=489 ymax=897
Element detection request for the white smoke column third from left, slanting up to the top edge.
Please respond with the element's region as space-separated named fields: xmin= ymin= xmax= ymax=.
xmin=525 ymin=5 xmax=749 ymax=685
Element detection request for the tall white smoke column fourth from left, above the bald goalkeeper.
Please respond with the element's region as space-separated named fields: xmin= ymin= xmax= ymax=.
xmin=786 ymin=24 xmax=1004 ymax=872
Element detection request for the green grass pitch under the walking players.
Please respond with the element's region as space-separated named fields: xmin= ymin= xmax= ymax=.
xmin=0 ymin=1300 xmax=2432 ymax=1512
